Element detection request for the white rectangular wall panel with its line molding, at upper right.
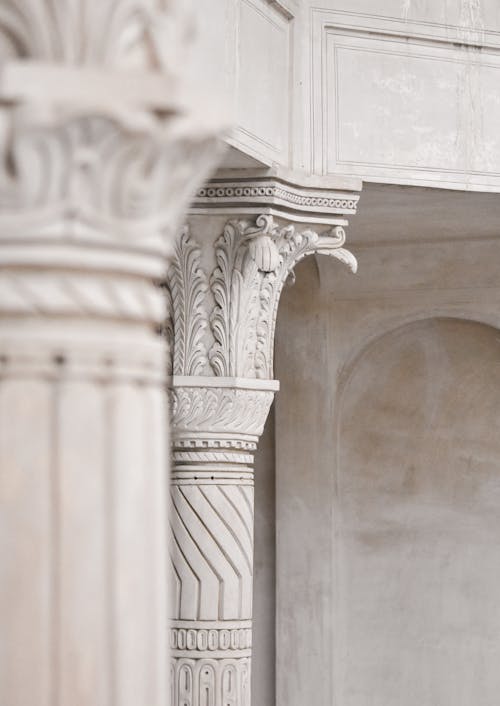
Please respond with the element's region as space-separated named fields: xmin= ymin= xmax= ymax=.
xmin=312 ymin=11 xmax=500 ymax=190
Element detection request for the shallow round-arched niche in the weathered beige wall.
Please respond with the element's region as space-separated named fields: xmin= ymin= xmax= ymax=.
xmin=332 ymin=318 xmax=500 ymax=706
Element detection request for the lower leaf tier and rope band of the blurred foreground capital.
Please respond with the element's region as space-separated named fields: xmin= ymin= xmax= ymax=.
xmin=0 ymin=113 xmax=221 ymax=326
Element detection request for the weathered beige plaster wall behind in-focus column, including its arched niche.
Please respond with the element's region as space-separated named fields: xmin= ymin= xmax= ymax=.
xmin=270 ymin=187 xmax=500 ymax=706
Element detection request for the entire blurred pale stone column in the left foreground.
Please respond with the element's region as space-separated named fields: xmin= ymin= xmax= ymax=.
xmin=0 ymin=0 xmax=223 ymax=706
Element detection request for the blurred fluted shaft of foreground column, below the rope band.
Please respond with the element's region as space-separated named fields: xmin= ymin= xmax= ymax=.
xmin=0 ymin=317 xmax=167 ymax=706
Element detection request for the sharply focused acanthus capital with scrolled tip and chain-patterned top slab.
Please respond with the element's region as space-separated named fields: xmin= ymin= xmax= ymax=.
xmin=167 ymin=169 xmax=359 ymax=379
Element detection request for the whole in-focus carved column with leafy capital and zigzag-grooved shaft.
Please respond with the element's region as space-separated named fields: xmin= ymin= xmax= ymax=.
xmin=167 ymin=173 xmax=358 ymax=706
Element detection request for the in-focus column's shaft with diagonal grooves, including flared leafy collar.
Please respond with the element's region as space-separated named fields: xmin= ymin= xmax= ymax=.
xmin=170 ymin=377 xmax=275 ymax=706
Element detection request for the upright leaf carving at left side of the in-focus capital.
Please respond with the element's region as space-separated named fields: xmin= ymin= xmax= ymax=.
xmin=167 ymin=227 xmax=208 ymax=375
